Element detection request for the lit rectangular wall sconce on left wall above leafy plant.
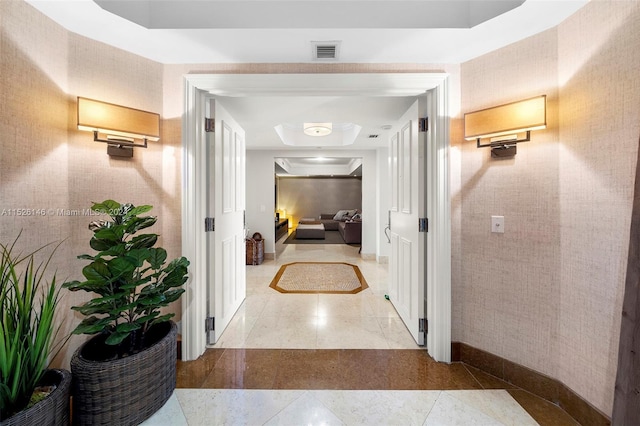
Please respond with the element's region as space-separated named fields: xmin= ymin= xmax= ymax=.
xmin=78 ymin=97 xmax=160 ymax=157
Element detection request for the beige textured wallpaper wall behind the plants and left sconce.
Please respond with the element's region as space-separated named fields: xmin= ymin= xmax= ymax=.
xmin=0 ymin=1 xmax=168 ymax=366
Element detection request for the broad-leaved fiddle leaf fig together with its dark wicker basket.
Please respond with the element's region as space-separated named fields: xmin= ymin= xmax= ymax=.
xmin=63 ymin=200 xmax=189 ymax=424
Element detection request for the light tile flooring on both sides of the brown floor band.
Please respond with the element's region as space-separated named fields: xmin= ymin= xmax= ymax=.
xmin=144 ymin=239 xmax=556 ymax=425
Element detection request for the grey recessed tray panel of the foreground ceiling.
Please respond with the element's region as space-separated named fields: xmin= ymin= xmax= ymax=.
xmin=94 ymin=0 xmax=524 ymax=29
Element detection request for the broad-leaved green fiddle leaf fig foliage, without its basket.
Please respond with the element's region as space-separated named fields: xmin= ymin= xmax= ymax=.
xmin=63 ymin=200 xmax=189 ymax=357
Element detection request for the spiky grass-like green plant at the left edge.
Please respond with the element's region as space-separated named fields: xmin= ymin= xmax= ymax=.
xmin=0 ymin=235 xmax=59 ymax=419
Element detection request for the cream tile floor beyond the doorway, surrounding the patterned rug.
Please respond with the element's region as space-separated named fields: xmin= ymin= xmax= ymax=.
xmin=211 ymin=240 xmax=420 ymax=349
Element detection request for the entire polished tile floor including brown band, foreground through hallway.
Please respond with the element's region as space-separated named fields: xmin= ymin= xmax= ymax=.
xmin=145 ymin=235 xmax=577 ymax=425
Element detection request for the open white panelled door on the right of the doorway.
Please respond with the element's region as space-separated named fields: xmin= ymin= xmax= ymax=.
xmin=389 ymin=98 xmax=428 ymax=345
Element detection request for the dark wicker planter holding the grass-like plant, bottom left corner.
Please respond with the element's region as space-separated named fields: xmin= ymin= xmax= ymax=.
xmin=0 ymin=370 xmax=71 ymax=426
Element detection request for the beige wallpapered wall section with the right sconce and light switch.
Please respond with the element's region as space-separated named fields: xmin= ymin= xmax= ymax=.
xmin=456 ymin=26 xmax=560 ymax=377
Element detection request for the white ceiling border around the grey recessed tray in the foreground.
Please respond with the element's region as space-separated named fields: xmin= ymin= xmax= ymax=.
xmin=26 ymin=0 xmax=588 ymax=64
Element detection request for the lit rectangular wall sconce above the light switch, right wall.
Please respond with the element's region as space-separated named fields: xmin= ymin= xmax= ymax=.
xmin=464 ymin=95 xmax=547 ymax=158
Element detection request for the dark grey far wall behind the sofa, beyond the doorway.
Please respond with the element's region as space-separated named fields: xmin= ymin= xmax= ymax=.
xmin=276 ymin=177 xmax=362 ymax=225
